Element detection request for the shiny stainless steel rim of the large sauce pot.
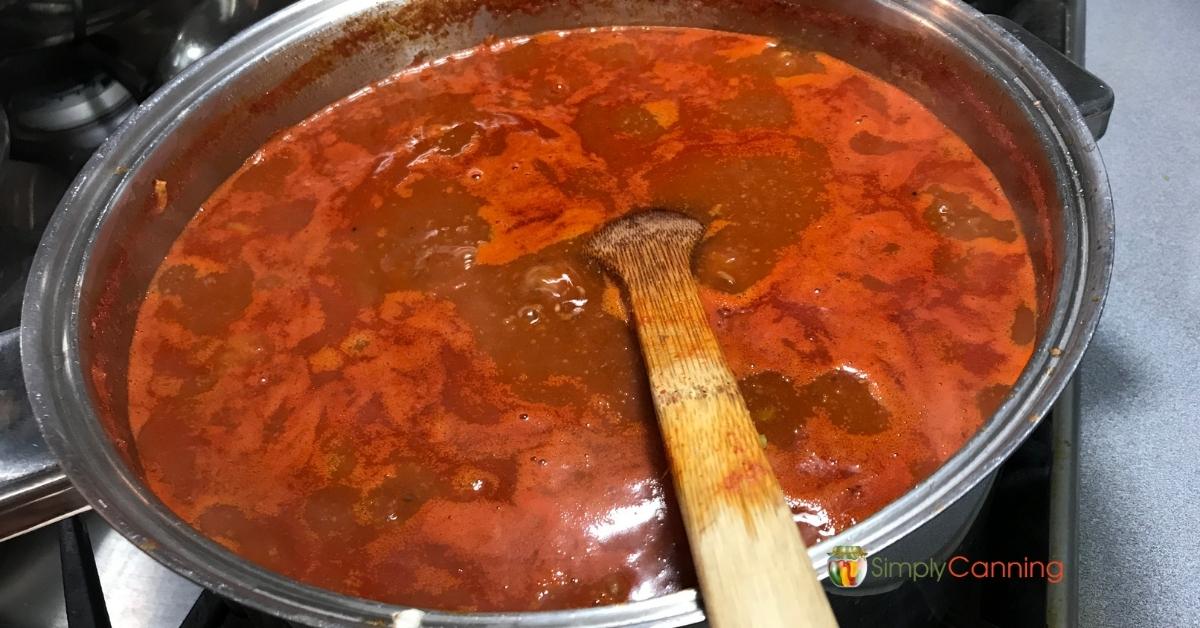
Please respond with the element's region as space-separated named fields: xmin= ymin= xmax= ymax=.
xmin=20 ymin=0 xmax=1114 ymax=627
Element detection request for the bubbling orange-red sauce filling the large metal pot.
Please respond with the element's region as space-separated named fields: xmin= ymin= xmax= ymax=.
xmin=128 ymin=28 xmax=1036 ymax=610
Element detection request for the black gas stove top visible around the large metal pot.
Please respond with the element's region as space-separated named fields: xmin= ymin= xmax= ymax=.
xmin=0 ymin=0 xmax=1106 ymax=628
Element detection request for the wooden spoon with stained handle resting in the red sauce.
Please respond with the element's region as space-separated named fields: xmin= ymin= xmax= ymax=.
xmin=587 ymin=210 xmax=838 ymax=628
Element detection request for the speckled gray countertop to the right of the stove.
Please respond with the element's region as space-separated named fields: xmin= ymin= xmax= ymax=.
xmin=1079 ymin=0 xmax=1200 ymax=628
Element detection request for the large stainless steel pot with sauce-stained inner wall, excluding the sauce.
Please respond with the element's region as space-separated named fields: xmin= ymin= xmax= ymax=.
xmin=22 ymin=0 xmax=1112 ymax=626
